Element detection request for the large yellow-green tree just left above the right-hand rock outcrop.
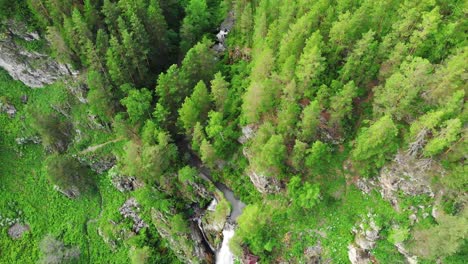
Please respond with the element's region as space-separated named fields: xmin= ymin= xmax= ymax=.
xmin=351 ymin=115 xmax=398 ymax=175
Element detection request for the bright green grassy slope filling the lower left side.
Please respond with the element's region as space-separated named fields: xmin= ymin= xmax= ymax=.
xmin=0 ymin=71 xmax=128 ymax=263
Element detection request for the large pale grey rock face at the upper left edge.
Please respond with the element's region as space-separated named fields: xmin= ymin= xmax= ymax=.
xmin=0 ymin=23 xmax=78 ymax=88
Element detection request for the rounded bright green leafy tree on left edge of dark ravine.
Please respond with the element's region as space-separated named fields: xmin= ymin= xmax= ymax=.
xmin=120 ymin=88 xmax=152 ymax=124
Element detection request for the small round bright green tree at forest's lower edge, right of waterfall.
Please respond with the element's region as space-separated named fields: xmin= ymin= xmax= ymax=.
xmin=288 ymin=176 xmax=320 ymax=209
